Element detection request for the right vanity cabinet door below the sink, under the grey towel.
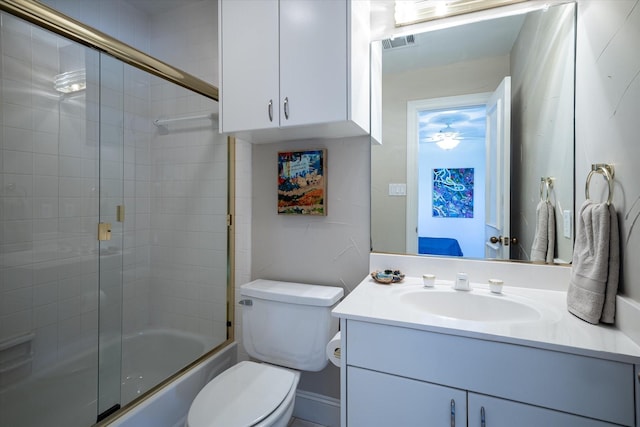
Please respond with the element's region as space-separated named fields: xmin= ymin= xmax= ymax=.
xmin=468 ymin=390 xmax=618 ymax=427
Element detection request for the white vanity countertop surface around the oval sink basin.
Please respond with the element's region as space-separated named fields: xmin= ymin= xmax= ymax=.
xmin=332 ymin=276 xmax=640 ymax=363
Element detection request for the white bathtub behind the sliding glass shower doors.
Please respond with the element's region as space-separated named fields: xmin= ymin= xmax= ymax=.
xmin=0 ymin=330 xmax=235 ymax=427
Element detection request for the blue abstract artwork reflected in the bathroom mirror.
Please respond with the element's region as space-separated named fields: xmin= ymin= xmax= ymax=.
xmin=433 ymin=168 xmax=474 ymax=218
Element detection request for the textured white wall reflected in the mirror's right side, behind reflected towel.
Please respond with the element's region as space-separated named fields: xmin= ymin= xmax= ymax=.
xmin=511 ymin=5 xmax=575 ymax=262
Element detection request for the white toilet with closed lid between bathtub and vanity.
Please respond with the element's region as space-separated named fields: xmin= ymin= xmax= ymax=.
xmin=187 ymin=279 xmax=343 ymax=427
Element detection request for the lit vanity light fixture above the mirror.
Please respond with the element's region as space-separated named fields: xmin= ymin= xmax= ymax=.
xmin=395 ymin=0 xmax=527 ymax=27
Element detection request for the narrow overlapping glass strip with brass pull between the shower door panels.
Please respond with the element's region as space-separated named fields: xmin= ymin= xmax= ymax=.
xmin=96 ymin=54 xmax=125 ymax=419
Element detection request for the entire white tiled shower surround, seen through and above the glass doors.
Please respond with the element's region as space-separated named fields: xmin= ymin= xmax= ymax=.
xmin=0 ymin=0 xmax=227 ymax=380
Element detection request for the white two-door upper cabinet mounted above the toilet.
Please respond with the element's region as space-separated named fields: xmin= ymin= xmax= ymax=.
xmin=219 ymin=0 xmax=370 ymax=142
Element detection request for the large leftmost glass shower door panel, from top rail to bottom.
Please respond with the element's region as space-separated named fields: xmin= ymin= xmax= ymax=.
xmin=0 ymin=13 xmax=100 ymax=427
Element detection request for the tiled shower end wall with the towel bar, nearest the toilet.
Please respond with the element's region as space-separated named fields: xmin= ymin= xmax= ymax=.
xmin=150 ymin=1 xmax=227 ymax=343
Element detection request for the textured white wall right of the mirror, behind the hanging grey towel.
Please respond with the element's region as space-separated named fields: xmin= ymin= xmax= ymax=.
xmin=575 ymin=0 xmax=640 ymax=302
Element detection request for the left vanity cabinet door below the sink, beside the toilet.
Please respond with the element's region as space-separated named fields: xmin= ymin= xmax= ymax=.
xmin=347 ymin=366 xmax=467 ymax=427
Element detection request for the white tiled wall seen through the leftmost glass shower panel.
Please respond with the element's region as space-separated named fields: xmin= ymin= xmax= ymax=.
xmin=0 ymin=14 xmax=98 ymax=379
